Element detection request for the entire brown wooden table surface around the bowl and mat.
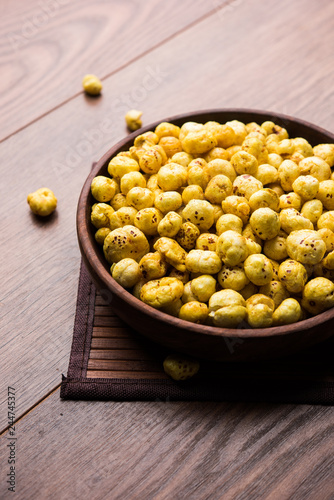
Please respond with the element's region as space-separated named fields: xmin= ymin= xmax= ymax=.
xmin=0 ymin=0 xmax=334 ymax=500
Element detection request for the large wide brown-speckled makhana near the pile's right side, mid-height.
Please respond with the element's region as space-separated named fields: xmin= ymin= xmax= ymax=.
xmin=286 ymin=229 xmax=326 ymax=265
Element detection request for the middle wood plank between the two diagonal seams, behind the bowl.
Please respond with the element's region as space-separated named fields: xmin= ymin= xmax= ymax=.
xmin=0 ymin=0 xmax=334 ymax=428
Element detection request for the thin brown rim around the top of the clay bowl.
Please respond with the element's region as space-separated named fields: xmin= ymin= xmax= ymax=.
xmin=76 ymin=108 xmax=334 ymax=339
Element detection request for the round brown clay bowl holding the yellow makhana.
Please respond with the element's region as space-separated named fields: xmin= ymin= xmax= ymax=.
xmin=77 ymin=109 xmax=334 ymax=362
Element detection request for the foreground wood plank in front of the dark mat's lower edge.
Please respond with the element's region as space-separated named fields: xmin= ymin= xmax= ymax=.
xmin=0 ymin=392 xmax=334 ymax=500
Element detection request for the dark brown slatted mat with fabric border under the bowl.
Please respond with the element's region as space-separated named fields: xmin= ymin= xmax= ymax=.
xmin=60 ymin=264 xmax=334 ymax=405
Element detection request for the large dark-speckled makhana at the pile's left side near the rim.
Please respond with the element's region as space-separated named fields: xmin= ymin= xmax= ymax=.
xmin=103 ymin=225 xmax=150 ymax=264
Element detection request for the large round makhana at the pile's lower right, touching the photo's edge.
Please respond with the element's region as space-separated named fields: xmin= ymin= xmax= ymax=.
xmin=302 ymin=278 xmax=334 ymax=315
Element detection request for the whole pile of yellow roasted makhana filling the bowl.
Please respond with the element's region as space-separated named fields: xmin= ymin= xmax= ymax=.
xmin=91 ymin=120 xmax=334 ymax=328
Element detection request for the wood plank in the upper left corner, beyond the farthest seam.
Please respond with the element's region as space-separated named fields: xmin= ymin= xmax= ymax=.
xmin=0 ymin=0 xmax=215 ymax=140
